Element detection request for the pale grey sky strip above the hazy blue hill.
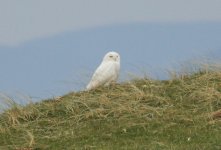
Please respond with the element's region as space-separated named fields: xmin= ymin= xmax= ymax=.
xmin=0 ymin=0 xmax=221 ymax=46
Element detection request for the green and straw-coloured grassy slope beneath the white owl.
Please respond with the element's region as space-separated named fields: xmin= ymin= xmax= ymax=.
xmin=0 ymin=72 xmax=221 ymax=150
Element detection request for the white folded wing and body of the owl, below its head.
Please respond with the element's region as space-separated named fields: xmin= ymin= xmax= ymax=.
xmin=87 ymin=63 xmax=118 ymax=90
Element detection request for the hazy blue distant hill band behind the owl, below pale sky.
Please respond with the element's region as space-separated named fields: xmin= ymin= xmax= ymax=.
xmin=0 ymin=23 xmax=221 ymax=104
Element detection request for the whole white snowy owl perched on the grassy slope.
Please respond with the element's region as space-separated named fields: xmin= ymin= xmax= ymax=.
xmin=86 ymin=52 xmax=120 ymax=90
